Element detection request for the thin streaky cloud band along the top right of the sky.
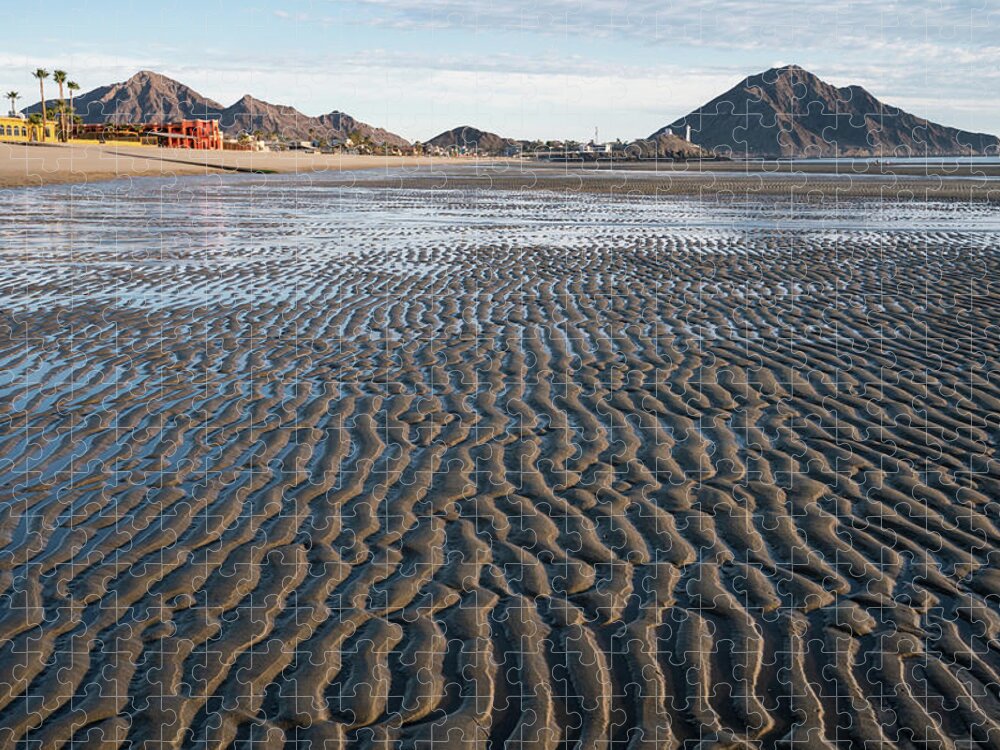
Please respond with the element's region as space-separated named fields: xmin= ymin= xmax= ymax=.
xmin=328 ymin=0 xmax=1000 ymax=48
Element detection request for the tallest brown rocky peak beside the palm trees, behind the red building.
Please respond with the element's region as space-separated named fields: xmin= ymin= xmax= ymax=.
xmin=23 ymin=70 xmax=222 ymax=124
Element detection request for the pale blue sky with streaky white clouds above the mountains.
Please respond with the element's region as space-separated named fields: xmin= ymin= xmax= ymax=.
xmin=0 ymin=0 xmax=1000 ymax=140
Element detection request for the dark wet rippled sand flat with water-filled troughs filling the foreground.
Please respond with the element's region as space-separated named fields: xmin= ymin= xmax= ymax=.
xmin=0 ymin=179 xmax=1000 ymax=750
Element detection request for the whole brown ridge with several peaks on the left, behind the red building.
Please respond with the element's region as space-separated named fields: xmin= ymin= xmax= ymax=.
xmin=23 ymin=70 xmax=409 ymax=146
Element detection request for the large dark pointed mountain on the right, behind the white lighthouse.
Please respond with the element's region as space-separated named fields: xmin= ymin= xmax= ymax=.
xmin=650 ymin=65 xmax=1000 ymax=157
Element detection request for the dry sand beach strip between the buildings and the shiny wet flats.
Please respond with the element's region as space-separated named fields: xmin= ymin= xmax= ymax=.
xmin=0 ymin=144 xmax=1000 ymax=202
